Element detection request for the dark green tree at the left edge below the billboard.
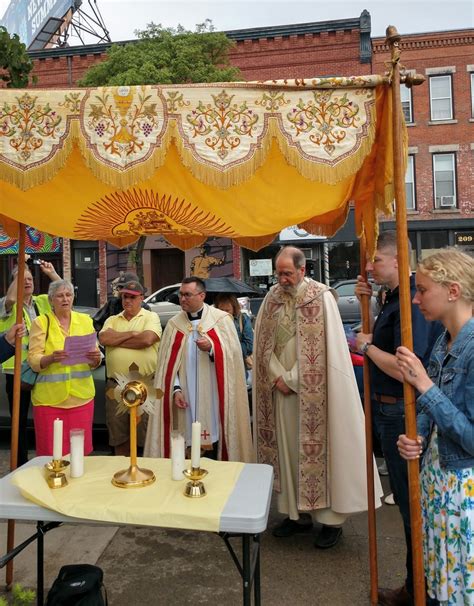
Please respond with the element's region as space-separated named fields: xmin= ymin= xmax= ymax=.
xmin=0 ymin=26 xmax=33 ymax=88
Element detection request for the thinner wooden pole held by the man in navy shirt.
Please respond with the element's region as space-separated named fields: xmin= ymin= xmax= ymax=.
xmin=360 ymin=236 xmax=379 ymax=606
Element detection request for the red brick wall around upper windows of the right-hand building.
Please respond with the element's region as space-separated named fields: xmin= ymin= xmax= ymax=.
xmin=373 ymin=30 xmax=474 ymax=220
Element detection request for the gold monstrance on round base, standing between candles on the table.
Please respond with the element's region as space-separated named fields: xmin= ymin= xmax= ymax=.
xmin=112 ymin=381 xmax=156 ymax=488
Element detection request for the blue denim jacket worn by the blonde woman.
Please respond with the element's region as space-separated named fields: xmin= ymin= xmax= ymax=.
xmin=417 ymin=318 xmax=474 ymax=470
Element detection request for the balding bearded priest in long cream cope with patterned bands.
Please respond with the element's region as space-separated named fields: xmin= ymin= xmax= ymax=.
xmin=253 ymin=246 xmax=382 ymax=549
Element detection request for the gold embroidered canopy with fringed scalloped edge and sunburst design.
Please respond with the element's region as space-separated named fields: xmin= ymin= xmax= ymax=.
xmin=0 ymin=76 xmax=400 ymax=255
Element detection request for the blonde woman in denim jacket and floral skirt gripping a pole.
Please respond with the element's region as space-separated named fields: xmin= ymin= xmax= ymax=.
xmin=396 ymin=249 xmax=474 ymax=606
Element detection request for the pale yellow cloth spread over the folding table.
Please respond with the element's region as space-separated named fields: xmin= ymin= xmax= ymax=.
xmin=12 ymin=457 xmax=244 ymax=532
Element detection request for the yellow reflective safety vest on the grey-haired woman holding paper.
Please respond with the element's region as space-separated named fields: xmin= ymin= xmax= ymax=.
xmin=31 ymin=311 xmax=95 ymax=406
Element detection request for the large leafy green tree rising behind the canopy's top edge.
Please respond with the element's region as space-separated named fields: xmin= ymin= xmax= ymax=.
xmin=78 ymin=19 xmax=240 ymax=283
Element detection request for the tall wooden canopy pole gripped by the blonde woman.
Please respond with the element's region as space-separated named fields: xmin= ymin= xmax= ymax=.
xmin=386 ymin=26 xmax=426 ymax=606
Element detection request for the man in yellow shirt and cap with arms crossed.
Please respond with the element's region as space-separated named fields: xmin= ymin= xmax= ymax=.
xmin=99 ymin=280 xmax=161 ymax=456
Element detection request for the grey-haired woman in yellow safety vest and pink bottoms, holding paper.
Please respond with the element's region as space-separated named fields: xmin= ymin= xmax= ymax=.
xmin=28 ymin=280 xmax=101 ymax=456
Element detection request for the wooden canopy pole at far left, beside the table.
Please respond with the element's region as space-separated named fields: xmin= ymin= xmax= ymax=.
xmin=5 ymin=223 xmax=25 ymax=589
